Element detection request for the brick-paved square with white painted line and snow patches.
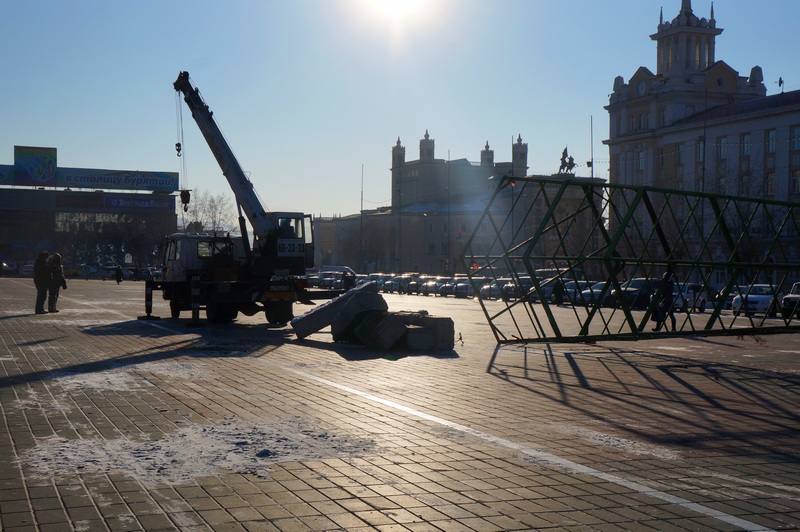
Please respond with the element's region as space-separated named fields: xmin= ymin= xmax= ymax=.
xmin=0 ymin=278 xmax=800 ymax=531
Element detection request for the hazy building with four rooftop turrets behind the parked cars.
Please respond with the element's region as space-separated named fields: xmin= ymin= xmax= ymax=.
xmin=315 ymin=131 xmax=528 ymax=275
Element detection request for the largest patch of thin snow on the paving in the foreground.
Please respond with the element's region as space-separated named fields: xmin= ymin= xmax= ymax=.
xmin=20 ymin=417 xmax=376 ymax=483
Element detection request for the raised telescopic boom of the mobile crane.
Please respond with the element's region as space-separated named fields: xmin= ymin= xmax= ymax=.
xmin=173 ymin=71 xmax=278 ymax=238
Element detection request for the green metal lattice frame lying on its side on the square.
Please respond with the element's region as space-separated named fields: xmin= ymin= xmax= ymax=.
xmin=461 ymin=175 xmax=800 ymax=344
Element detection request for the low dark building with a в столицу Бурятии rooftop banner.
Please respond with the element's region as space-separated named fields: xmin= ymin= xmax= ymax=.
xmin=0 ymin=146 xmax=178 ymax=266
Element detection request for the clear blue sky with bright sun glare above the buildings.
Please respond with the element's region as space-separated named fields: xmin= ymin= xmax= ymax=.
xmin=0 ymin=0 xmax=800 ymax=216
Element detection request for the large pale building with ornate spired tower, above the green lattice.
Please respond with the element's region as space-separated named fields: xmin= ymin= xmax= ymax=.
xmin=604 ymin=0 xmax=800 ymax=282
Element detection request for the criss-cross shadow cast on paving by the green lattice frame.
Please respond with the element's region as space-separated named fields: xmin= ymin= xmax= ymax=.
xmin=488 ymin=345 xmax=800 ymax=461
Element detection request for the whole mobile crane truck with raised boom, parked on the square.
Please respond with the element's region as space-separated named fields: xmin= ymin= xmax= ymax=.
xmin=142 ymin=72 xmax=324 ymax=324
